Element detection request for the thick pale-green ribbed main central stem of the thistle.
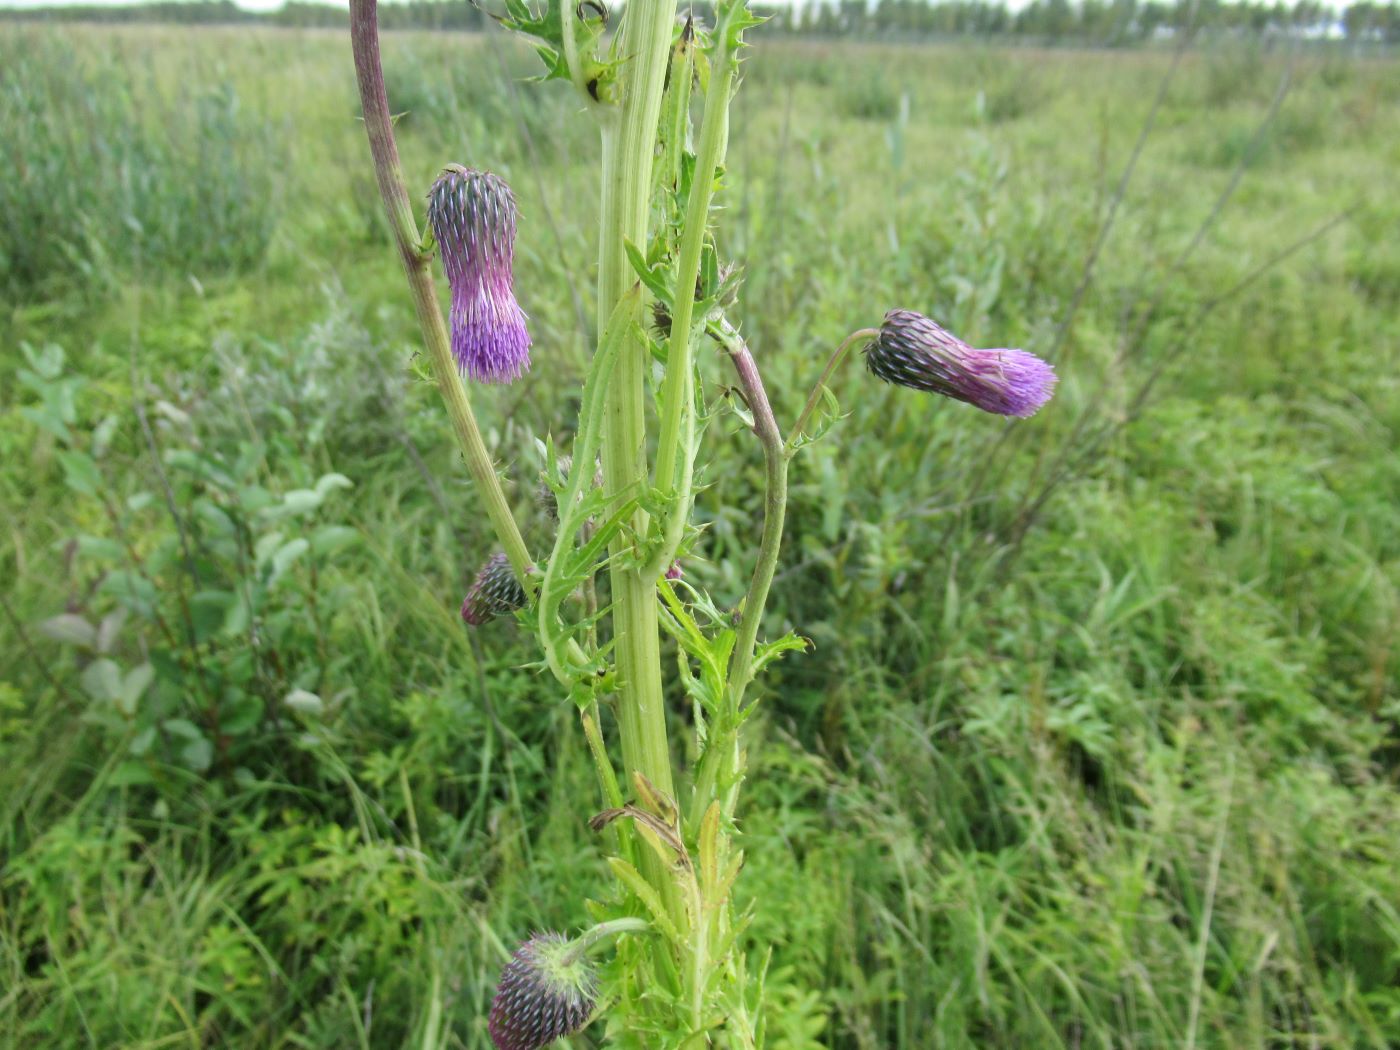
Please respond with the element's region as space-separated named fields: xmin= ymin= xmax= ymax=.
xmin=598 ymin=0 xmax=679 ymax=890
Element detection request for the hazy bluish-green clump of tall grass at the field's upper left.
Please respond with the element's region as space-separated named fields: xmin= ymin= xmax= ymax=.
xmin=0 ymin=28 xmax=286 ymax=297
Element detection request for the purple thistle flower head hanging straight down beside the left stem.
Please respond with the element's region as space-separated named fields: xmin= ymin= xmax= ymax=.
xmin=428 ymin=164 xmax=529 ymax=382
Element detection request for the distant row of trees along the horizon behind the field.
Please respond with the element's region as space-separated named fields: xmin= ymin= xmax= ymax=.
xmin=0 ymin=0 xmax=1400 ymax=46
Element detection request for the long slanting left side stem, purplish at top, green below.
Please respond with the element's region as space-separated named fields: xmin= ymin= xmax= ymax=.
xmin=350 ymin=0 xmax=535 ymax=592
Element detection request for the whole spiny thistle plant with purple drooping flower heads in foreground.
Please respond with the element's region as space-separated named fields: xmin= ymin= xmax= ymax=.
xmin=350 ymin=0 xmax=1054 ymax=1050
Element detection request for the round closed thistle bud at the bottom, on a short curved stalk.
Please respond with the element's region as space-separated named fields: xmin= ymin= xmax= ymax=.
xmin=487 ymin=934 xmax=598 ymax=1050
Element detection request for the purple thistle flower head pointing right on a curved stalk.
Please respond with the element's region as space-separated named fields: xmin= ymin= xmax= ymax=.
xmin=865 ymin=309 xmax=1057 ymax=419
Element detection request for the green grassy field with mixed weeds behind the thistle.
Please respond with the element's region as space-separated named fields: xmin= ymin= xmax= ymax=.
xmin=0 ymin=25 xmax=1400 ymax=1050
